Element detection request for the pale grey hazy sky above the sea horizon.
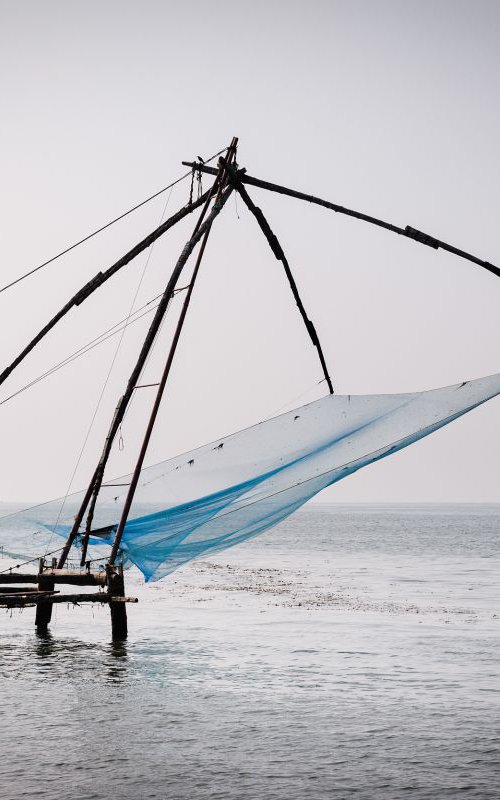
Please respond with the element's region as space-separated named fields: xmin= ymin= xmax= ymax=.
xmin=0 ymin=0 xmax=500 ymax=502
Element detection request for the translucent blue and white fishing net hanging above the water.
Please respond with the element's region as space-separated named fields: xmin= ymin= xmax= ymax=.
xmin=0 ymin=374 xmax=500 ymax=580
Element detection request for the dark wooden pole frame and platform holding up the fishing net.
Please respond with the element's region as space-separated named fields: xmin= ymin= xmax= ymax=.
xmin=0 ymin=137 xmax=500 ymax=639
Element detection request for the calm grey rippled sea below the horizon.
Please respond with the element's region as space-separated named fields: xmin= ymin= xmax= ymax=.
xmin=0 ymin=506 xmax=500 ymax=800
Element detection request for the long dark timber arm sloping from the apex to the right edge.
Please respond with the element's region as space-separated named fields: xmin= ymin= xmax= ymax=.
xmin=182 ymin=161 xmax=500 ymax=278
